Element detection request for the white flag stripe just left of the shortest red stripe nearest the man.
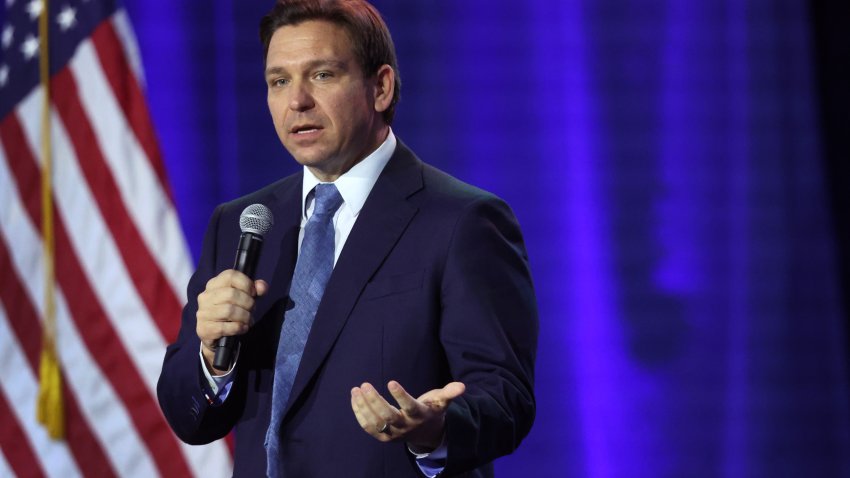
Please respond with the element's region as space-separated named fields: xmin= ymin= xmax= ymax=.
xmin=70 ymin=40 xmax=191 ymax=302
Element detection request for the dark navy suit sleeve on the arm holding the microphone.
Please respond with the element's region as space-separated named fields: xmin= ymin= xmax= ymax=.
xmin=157 ymin=206 xmax=242 ymax=445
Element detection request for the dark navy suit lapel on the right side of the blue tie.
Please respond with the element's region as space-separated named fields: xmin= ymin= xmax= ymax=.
xmin=286 ymin=141 xmax=422 ymax=413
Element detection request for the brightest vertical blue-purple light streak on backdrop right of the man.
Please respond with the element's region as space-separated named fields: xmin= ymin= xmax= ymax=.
xmin=548 ymin=2 xmax=620 ymax=477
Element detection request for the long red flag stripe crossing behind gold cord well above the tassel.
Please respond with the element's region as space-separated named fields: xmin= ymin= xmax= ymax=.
xmin=4 ymin=114 xmax=190 ymax=476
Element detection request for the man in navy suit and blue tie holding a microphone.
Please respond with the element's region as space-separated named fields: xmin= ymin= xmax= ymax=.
xmin=158 ymin=0 xmax=537 ymax=478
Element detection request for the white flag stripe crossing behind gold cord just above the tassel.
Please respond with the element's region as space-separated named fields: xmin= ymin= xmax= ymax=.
xmin=0 ymin=136 xmax=158 ymax=476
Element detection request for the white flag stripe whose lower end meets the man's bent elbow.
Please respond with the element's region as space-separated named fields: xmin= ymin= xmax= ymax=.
xmin=19 ymin=88 xmax=166 ymax=396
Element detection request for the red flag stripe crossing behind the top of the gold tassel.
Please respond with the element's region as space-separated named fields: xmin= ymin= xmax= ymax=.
xmin=0 ymin=234 xmax=117 ymax=477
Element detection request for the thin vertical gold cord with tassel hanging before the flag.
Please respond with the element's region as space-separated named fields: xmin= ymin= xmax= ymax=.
xmin=36 ymin=0 xmax=65 ymax=440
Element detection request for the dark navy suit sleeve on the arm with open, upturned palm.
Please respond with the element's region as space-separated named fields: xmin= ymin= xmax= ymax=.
xmin=440 ymin=197 xmax=538 ymax=476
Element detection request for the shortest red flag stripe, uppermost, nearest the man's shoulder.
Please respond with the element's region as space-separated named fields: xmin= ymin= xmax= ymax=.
xmin=91 ymin=22 xmax=174 ymax=204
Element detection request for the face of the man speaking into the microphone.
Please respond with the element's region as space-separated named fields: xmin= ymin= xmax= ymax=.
xmin=266 ymin=21 xmax=385 ymax=178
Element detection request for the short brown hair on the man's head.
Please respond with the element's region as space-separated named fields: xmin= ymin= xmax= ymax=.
xmin=260 ymin=0 xmax=401 ymax=125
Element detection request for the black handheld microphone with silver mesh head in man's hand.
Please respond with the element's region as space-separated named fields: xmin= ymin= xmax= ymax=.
xmin=213 ymin=204 xmax=274 ymax=370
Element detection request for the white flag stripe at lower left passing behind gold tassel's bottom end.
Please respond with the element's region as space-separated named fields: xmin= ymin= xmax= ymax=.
xmin=0 ymin=303 xmax=80 ymax=477
